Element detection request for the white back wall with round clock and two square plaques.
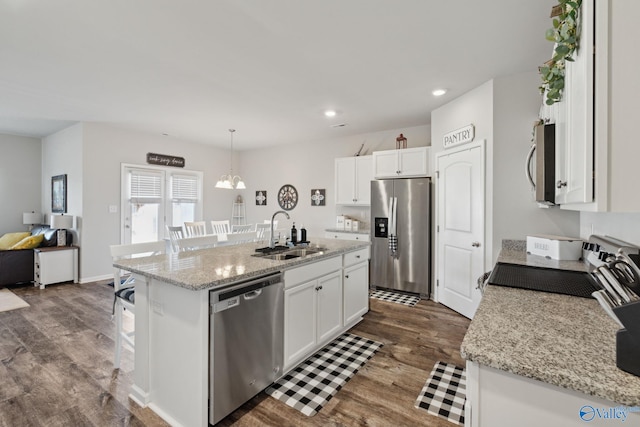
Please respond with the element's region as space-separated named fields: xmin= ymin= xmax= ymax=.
xmin=238 ymin=126 xmax=430 ymax=238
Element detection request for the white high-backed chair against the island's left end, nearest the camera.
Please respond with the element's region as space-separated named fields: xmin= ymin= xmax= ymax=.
xmin=109 ymin=241 xmax=167 ymax=369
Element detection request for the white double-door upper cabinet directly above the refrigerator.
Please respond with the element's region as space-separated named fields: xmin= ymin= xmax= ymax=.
xmin=373 ymin=147 xmax=431 ymax=178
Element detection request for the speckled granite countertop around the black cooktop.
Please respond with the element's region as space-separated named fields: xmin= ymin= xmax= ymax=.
xmin=460 ymin=241 xmax=640 ymax=406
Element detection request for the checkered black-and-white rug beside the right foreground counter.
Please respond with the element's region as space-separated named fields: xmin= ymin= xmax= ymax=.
xmin=415 ymin=362 xmax=467 ymax=426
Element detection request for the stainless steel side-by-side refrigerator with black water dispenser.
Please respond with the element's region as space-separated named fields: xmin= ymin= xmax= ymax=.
xmin=369 ymin=178 xmax=431 ymax=296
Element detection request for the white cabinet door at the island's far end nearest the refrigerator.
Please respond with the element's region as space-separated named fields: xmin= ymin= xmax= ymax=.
xmin=342 ymin=261 xmax=369 ymax=325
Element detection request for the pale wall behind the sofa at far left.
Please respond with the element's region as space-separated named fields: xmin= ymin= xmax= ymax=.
xmin=0 ymin=134 xmax=42 ymax=235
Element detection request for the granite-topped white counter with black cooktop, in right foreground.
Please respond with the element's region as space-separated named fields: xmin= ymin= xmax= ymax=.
xmin=461 ymin=242 xmax=640 ymax=427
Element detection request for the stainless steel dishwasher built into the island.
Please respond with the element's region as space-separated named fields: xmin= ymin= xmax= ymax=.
xmin=209 ymin=273 xmax=284 ymax=424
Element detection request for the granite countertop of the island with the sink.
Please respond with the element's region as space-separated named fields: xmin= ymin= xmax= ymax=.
xmin=113 ymin=238 xmax=370 ymax=291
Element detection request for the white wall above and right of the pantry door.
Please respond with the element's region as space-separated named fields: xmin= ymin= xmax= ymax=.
xmin=431 ymin=73 xmax=579 ymax=268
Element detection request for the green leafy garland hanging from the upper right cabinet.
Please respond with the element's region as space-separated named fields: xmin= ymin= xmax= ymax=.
xmin=539 ymin=0 xmax=582 ymax=105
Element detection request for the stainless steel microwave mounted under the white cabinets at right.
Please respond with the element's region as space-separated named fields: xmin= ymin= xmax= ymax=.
xmin=526 ymin=124 xmax=556 ymax=206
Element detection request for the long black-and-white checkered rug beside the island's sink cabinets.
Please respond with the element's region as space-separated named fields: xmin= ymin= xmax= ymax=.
xmin=266 ymin=333 xmax=382 ymax=417
